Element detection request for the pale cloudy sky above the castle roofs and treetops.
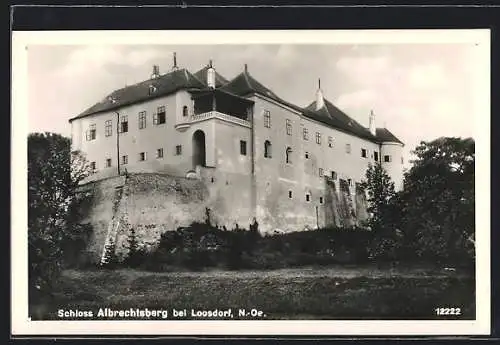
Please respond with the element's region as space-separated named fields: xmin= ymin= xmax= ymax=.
xmin=27 ymin=43 xmax=479 ymax=165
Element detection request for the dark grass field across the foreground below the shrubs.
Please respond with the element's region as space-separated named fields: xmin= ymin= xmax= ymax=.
xmin=30 ymin=266 xmax=475 ymax=319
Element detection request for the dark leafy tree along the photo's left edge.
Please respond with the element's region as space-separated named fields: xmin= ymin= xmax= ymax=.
xmin=28 ymin=133 xmax=90 ymax=304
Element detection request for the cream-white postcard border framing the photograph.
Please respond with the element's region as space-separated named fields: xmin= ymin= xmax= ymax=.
xmin=11 ymin=29 xmax=491 ymax=335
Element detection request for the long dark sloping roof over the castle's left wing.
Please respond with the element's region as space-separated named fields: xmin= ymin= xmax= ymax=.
xmin=69 ymin=69 xmax=205 ymax=122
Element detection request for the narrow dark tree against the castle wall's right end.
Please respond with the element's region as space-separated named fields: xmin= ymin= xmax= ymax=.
xmin=360 ymin=163 xmax=401 ymax=259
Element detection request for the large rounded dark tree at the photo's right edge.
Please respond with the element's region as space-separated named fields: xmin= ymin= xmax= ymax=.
xmin=401 ymin=137 xmax=475 ymax=261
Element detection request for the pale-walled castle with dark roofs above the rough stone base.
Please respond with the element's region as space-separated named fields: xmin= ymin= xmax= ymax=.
xmin=69 ymin=55 xmax=404 ymax=230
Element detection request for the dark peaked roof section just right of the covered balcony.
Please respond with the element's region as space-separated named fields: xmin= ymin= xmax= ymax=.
xmin=221 ymin=71 xmax=302 ymax=112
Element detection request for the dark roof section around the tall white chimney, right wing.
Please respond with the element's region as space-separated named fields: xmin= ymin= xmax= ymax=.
xmin=304 ymin=99 xmax=377 ymax=141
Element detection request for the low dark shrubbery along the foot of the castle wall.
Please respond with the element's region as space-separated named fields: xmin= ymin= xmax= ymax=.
xmin=117 ymin=222 xmax=372 ymax=271
